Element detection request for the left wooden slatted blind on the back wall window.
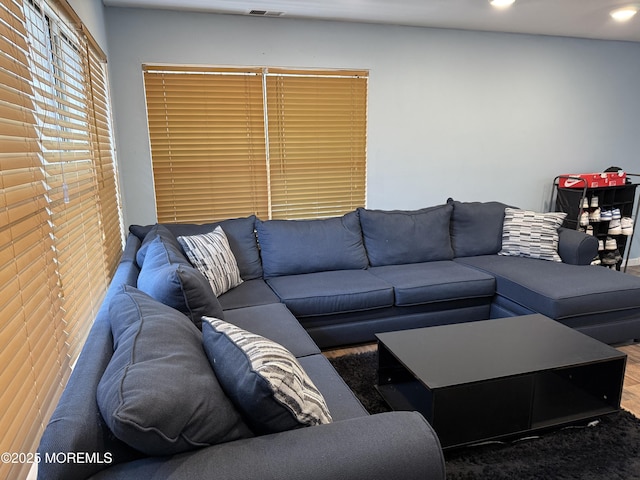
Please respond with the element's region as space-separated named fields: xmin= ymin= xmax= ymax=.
xmin=144 ymin=67 xmax=268 ymax=223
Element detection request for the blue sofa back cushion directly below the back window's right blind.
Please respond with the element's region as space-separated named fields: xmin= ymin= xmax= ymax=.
xmin=256 ymin=212 xmax=368 ymax=278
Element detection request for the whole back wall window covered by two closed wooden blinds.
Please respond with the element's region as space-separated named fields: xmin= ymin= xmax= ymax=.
xmin=144 ymin=66 xmax=367 ymax=223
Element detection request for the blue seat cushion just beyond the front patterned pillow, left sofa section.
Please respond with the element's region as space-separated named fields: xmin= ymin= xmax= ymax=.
xmin=224 ymin=304 xmax=320 ymax=357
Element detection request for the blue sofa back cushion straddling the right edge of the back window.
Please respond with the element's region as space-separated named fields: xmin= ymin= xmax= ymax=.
xmin=358 ymin=205 xmax=453 ymax=267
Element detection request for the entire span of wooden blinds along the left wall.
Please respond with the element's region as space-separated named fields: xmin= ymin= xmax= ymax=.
xmin=0 ymin=0 xmax=122 ymax=478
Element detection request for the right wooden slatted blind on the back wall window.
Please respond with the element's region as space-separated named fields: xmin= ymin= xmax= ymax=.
xmin=266 ymin=70 xmax=367 ymax=218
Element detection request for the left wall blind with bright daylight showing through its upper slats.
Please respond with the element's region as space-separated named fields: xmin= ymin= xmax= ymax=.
xmin=27 ymin=0 xmax=108 ymax=358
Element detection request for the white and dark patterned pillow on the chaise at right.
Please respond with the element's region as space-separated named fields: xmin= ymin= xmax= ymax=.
xmin=498 ymin=208 xmax=567 ymax=262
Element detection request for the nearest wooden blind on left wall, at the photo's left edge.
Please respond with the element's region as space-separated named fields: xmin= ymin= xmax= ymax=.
xmin=0 ymin=1 xmax=68 ymax=478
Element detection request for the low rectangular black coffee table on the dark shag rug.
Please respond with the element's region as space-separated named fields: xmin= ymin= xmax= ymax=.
xmin=376 ymin=315 xmax=627 ymax=448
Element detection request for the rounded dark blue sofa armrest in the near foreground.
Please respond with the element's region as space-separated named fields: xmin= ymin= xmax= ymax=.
xmin=93 ymin=412 xmax=445 ymax=480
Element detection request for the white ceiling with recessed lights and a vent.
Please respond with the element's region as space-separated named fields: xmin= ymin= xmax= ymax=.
xmin=103 ymin=0 xmax=640 ymax=42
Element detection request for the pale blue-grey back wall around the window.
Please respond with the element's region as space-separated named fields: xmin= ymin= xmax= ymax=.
xmin=106 ymin=8 xmax=640 ymax=257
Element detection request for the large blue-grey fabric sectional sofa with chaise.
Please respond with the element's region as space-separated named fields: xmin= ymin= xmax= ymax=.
xmin=39 ymin=199 xmax=640 ymax=480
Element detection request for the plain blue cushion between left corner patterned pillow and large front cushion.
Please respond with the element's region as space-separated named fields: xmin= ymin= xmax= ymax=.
xmin=137 ymin=236 xmax=224 ymax=328
